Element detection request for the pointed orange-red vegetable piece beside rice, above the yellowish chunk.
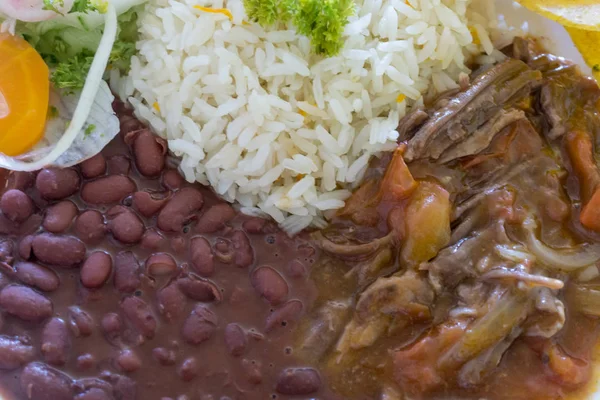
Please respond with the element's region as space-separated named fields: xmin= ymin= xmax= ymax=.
xmin=379 ymin=145 xmax=417 ymax=201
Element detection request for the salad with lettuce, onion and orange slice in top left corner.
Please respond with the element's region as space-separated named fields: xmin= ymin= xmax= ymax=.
xmin=0 ymin=0 xmax=145 ymax=171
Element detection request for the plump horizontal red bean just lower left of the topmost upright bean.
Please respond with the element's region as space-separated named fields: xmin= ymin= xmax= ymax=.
xmin=81 ymin=175 xmax=136 ymax=204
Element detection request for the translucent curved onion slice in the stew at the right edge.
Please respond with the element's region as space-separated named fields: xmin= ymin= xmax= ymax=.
xmin=523 ymin=217 xmax=600 ymax=271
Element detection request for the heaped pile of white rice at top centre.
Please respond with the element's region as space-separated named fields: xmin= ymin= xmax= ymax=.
xmin=112 ymin=0 xmax=506 ymax=233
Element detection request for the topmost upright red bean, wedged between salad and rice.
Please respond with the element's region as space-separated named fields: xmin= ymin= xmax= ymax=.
xmin=125 ymin=129 xmax=167 ymax=176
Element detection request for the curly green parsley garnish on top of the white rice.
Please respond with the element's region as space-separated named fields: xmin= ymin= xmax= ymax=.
xmin=244 ymin=0 xmax=354 ymax=57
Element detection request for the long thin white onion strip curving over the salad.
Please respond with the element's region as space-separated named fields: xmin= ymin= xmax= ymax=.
xmin=0 ymin=3 xmax=117 ymax=171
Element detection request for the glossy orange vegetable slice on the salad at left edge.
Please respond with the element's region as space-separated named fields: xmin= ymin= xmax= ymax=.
xmin=0 ymin=34 xmax=50 ymax=156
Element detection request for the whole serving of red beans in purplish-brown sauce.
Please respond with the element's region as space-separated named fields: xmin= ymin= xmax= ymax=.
xmin=0 ymin=120 xmax=338 ymax=400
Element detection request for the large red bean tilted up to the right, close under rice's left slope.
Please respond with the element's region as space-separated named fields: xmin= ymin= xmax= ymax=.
xmin=157 ymin=187 xmax=204 ymax=232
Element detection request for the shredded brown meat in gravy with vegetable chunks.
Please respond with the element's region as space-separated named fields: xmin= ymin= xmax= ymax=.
xmin=296 ymin=39 xmax=600 ymax=400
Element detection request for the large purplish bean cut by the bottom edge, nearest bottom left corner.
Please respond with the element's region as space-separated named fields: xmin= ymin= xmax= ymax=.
xmin=21 ymin=362 xmax=73 ymax=400
